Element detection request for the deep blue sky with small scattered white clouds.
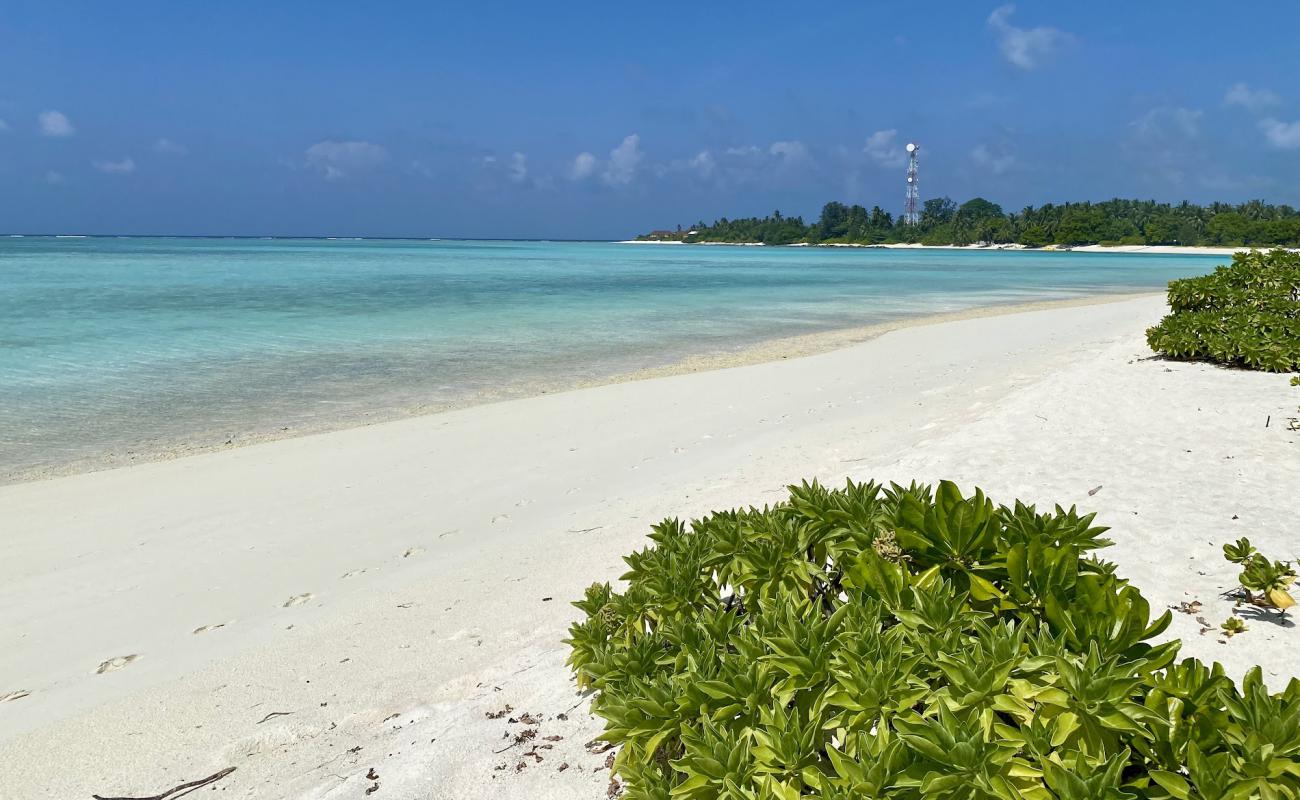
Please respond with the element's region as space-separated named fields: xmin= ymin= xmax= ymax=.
xmin=0 ymin=0 xmax=1300 ymax=238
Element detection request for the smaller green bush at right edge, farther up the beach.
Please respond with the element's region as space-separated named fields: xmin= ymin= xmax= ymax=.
xmin=1147 ymin=250 xmax=1300 ymax=372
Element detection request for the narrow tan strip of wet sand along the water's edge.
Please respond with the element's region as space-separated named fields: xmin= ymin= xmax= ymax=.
xmin=0 ymin=291 xmax=1164 ymax=487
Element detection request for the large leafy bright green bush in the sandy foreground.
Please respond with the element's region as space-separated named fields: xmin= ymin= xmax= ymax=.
xmin=568 ymin=483 xmax=1300 ymax=800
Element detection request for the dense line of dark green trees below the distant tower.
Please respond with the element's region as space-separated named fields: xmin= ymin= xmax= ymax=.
xmin=637 ymin=198 xmax=1300 ymax=247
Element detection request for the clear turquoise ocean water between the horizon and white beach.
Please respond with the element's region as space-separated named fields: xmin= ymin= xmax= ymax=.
xmin=0 ymin=237 xmax=1226 ymax=480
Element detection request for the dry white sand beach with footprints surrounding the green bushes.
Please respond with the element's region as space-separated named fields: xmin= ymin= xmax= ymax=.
xmin=0 ymin=295 xmax=1300 ymax=800
